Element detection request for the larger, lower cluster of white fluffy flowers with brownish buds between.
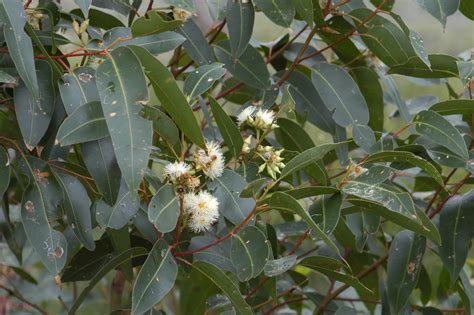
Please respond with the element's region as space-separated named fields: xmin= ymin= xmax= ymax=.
xmin=164 ymin=141 xmax=225 ymax=233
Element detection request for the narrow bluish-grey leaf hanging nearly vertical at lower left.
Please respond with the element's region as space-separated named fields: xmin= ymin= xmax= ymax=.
xmin=54 ymin=172 xmax=95 ymax=250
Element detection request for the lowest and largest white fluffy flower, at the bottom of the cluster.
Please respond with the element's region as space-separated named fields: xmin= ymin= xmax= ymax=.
xmin=183 ymin=191 xmax=219 ymax=233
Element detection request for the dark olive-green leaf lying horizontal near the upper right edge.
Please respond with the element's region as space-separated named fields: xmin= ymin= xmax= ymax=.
xmin=388 ymin=55 xmax=459 ymax=79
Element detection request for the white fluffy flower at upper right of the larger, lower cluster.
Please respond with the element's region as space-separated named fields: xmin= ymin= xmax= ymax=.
xmin=194 ymin=141 xmax=225 ymax=179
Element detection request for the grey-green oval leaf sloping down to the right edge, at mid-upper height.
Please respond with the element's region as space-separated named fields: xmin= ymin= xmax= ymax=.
xmin=413 ymin=110 xmax=469 ymax=160
